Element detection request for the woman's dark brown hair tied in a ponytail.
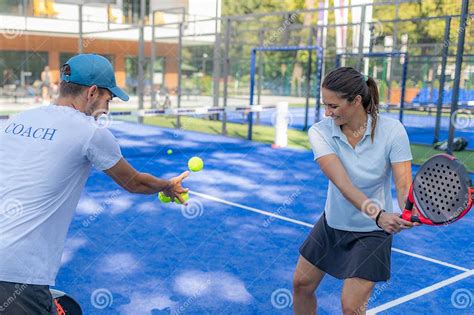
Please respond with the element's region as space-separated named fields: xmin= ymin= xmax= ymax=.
xmin=322 ymin=67 xmax=380 ymax=141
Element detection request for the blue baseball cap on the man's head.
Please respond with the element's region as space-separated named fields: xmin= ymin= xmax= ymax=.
xmin=61 ymin=54 xmax=129 ymax=101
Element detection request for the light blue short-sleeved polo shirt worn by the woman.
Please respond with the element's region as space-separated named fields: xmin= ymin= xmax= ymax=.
xmin=308 ymin=115 xmax=412 ymax=232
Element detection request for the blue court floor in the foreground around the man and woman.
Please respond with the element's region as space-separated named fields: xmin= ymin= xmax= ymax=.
xmin=56 ymin=122 xmax=474 ymax=315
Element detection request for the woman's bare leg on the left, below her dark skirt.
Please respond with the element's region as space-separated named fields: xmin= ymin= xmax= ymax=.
xmin=293 ymin=256 xmax=325 ymax=315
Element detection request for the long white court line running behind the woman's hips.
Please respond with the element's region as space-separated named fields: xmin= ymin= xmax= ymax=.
xmin=189 ymin=191 xmax=471 ymax=272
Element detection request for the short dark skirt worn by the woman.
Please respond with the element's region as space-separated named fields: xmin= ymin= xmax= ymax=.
xmin=300 ymin=214 xmax=392 ymax=282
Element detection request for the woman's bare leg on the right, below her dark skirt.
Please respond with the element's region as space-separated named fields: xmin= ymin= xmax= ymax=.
xmin=341 ymin=278 xmax=375 ymax=315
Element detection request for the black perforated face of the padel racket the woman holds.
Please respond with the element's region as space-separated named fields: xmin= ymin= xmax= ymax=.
xmin=413 ymin=155 xmax=470 ymax=224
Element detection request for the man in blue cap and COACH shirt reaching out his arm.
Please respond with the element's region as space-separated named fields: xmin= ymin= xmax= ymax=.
xmin=0 ymin=54 xmax=188 ymax=315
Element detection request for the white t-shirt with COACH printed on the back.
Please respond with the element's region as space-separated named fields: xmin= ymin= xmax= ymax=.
xmin=0 ymin=105 xmax=122 ymax=285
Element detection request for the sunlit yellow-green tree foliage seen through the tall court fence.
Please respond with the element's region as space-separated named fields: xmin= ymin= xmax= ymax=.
xmin=183 ymin=0 xmax=474 ymax=99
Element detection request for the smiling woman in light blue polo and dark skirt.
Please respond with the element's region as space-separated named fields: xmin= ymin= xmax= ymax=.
xmin=293 ymin=67 xmax=414 ymax=315
